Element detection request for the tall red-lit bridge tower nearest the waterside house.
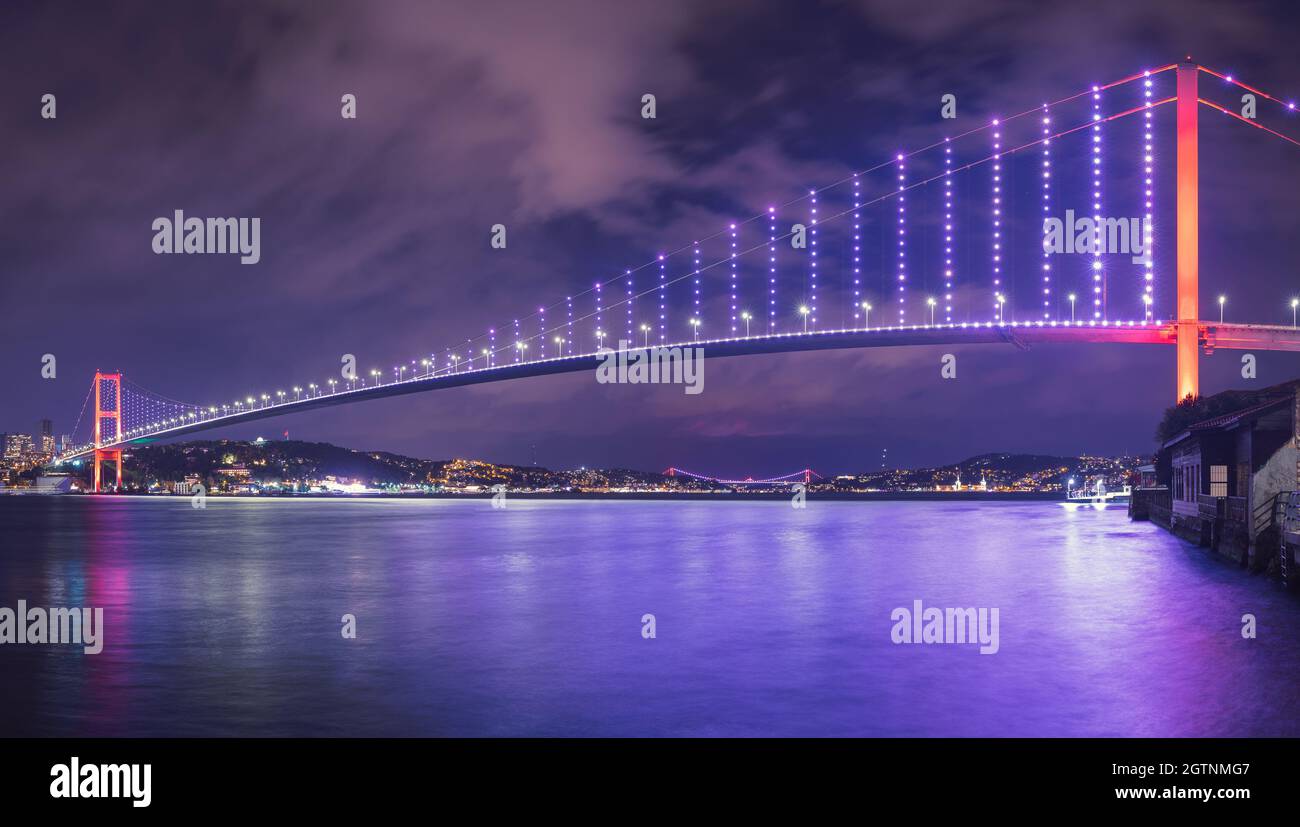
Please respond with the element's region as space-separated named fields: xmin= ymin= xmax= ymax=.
xmin=1177 ymin=62 xmax=1201 ymax=402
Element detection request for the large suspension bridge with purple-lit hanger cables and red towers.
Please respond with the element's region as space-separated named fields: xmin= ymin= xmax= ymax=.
xmin=53 ymin=61 xmax=1300 ymax=492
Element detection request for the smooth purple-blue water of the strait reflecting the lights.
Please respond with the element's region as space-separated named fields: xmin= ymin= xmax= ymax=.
xmin=0 ymin=497 xmax=1300 ymax=736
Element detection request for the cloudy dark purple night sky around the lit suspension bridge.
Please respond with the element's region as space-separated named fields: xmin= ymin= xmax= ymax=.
xmin=0 ymin=0 xmax=1300 ymax=475
